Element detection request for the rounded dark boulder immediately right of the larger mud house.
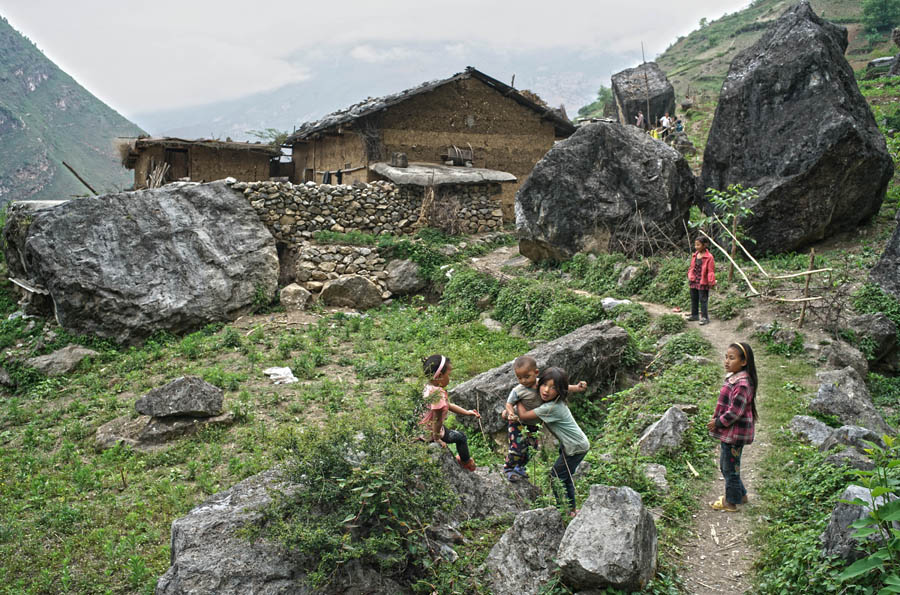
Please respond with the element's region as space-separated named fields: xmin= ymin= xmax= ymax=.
xmin=515 ymin=122 xmax=696 ymax=261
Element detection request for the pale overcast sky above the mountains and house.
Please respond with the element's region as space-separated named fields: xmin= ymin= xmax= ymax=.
xmin=0 ymin=0 xmax=749 ymax=117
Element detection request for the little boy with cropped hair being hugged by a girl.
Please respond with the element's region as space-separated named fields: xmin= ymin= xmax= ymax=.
xmin=501 ymin=355 xmax=587 ymax=482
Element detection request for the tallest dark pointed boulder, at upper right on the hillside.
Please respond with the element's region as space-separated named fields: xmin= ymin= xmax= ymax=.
xmin=700 ymin=0 xmax=893 ymax=253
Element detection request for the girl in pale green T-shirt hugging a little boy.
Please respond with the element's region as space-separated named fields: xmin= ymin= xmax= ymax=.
xmin=518 ymin=368 xmax=591 ymax=517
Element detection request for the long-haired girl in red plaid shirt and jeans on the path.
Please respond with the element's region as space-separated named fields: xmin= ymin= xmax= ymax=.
xmin=707 ymin=343 xmax=759 ymax=512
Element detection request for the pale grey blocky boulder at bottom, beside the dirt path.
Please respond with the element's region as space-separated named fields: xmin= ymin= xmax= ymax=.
xmin=556 ymin=485 xmax=657 ymax=591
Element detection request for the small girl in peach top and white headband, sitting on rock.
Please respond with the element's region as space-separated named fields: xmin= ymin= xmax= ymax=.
xmin=419 ymin=354 xmax=481 ymax=471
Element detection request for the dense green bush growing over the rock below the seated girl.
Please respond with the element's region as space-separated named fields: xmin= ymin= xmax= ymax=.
xmin=271 ymin=413 xmax=456 ymax=586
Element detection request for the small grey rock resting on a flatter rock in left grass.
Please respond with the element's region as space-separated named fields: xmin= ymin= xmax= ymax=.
xmin=134 ymin=376 xmax=224 ymax=417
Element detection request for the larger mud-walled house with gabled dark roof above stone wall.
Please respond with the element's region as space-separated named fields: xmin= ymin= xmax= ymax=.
xmin=287 ymin=67 xmax=575 ymax=221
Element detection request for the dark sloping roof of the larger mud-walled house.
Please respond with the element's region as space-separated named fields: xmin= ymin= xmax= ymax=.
xmin=285 ymin=66 xmax=575 ymax=144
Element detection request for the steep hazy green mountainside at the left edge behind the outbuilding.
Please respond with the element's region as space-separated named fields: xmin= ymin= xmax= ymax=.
xmin=0 ymin=17 xmax=145 ymax=205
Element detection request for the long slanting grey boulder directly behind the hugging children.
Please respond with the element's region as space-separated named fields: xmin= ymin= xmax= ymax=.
xmin=450 ymin=320 xmax=628 ymax=433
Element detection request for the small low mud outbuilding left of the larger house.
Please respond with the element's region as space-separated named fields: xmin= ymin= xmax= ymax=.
xmin=122 ymin=137 xmax=281 ymax=188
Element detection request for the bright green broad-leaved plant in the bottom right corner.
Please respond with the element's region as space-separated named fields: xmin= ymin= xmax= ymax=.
xmin=838 ymin=435 xmax=900 ymax=593
